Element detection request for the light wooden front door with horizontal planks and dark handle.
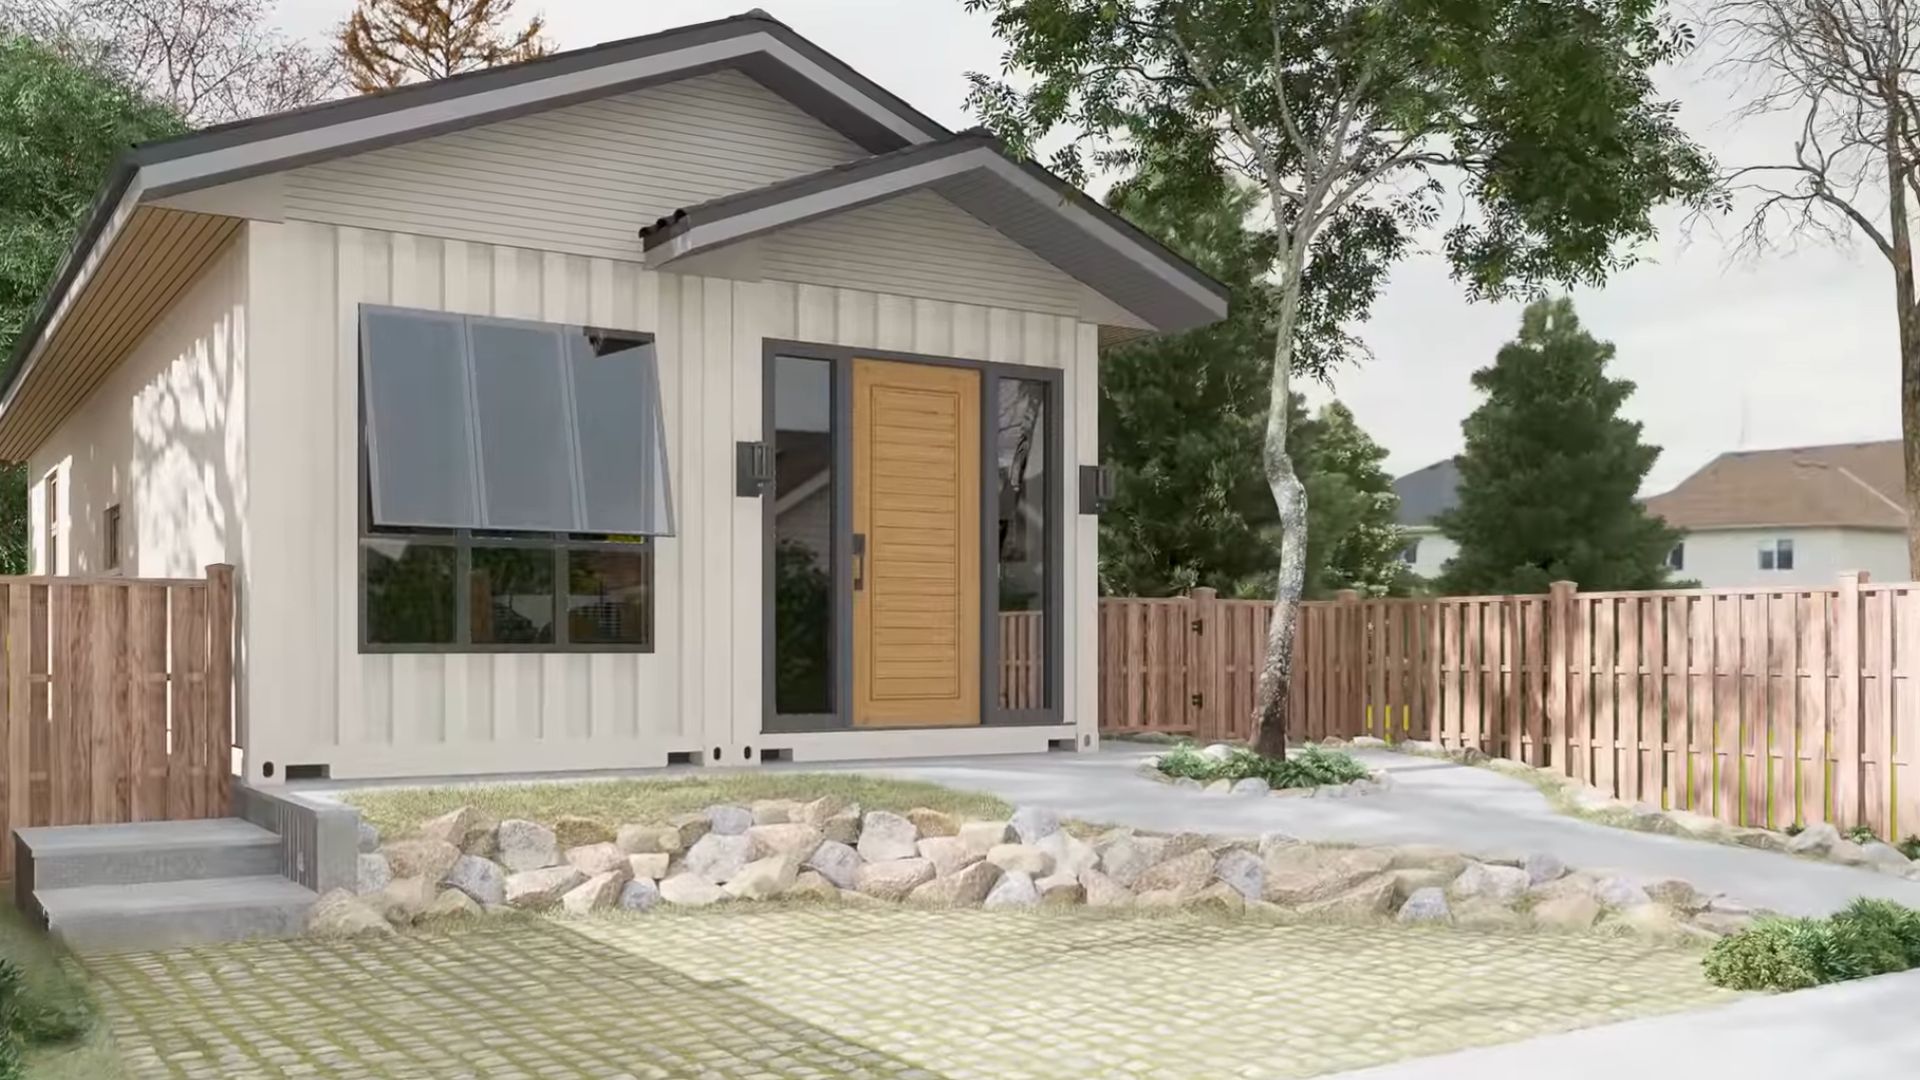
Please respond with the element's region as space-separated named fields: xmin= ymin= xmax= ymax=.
xmin=852 ymin=359 xmax=981 ymax=726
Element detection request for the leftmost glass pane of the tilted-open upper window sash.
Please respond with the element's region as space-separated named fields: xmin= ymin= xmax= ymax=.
xmin=361 ymin=307 xmax=478 ymax=528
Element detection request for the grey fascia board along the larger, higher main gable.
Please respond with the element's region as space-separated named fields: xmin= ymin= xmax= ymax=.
xmin=140 ymin=31 xmax=939 ymax=198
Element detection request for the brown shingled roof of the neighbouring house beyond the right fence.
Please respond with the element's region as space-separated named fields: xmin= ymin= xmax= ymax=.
xmin=1647 ymin=440 xmax=1907 ymax=532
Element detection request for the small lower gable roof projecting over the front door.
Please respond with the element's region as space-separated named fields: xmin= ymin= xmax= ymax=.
xmin=639 ymin=131 xmax=1229 ymax=331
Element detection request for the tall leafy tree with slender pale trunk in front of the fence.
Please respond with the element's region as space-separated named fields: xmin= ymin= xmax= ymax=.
xmin=964 ymin=0 xmax=1713 ymax=755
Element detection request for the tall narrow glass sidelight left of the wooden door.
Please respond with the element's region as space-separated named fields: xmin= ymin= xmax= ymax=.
xmin=774 ymin=356 xmax=835 ymax=715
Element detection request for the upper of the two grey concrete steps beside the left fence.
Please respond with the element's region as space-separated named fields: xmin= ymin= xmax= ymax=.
xmin=17 ymin=817 xmax=280 ymax=892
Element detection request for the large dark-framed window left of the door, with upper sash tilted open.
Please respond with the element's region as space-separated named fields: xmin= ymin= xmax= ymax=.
xmin=361 ymin=307 xmax=672 ymax=651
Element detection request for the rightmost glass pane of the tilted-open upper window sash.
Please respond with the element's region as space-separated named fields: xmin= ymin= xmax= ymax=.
xmin=566 ymin=329 xmax=674 ymax=536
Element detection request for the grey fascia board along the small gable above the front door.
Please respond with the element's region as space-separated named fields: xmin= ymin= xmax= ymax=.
xmin=647 ymin=142 xmax=1227 ymax=319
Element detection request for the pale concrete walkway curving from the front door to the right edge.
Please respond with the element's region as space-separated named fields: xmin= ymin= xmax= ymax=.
xmin=833 ymin=744 xmax=1920 ymax=915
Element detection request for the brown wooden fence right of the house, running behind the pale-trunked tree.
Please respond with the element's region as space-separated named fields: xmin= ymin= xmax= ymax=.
xmin=1100 ymin=575 xmax=1920 ymax=838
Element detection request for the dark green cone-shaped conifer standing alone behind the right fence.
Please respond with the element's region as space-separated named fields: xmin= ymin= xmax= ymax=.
xmin=1434 ymin=300 xmax=1680 ymax=594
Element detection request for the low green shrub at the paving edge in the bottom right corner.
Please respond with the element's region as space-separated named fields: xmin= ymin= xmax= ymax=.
xmin=1705 ymin=897 xmax=1920 ymax=990
